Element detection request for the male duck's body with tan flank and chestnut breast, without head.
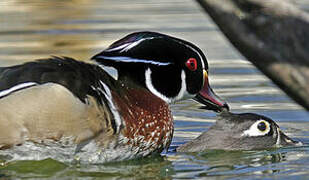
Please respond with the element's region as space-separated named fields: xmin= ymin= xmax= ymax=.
xmin=0 ymin=57 xmax=173 ymax=162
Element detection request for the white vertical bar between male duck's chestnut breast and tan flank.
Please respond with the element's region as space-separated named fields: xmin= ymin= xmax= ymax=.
xmin=100 ymin=81 xmax=122 ymax=133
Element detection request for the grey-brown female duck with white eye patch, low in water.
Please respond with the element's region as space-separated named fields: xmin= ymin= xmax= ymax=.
xmin=177 ymin=111 xmax=302 ymax=152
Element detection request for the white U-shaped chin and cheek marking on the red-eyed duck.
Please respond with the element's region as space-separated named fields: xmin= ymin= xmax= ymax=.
xmin=145 ymin=68 xmax=191 ymax=103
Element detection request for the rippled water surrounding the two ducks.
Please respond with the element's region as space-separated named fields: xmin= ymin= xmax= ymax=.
xmin=0 ymin=0 xmax=309 ymax=179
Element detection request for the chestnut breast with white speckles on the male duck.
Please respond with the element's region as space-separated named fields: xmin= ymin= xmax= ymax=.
xmin=113 ymin=89 xmax=173 ymax=152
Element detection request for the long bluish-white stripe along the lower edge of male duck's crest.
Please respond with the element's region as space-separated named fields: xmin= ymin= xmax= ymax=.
xmin=97 ymin=56 xmax=172 ymax=66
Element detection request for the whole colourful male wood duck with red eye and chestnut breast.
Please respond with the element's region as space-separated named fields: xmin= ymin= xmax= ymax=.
xmin=0 ymin=32 xmax=228 ymax=163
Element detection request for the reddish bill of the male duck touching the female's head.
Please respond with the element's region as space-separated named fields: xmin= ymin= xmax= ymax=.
xmin=193 ymin=70 xmax=229 ymax=112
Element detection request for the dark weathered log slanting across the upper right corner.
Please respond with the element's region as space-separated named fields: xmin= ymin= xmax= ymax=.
xmin=197 ymin=0 xmax=309 ymax=110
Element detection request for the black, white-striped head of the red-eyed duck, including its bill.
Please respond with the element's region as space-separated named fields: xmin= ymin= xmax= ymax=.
xmin=92 ymin=32 xmax=228 ymax=112
